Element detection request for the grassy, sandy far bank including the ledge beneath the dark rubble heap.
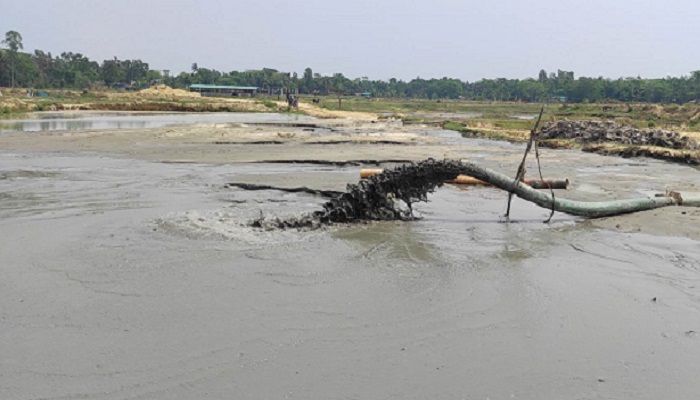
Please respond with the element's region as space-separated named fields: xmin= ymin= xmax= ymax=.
xmin=0 ymin=87 xmax=700 ymax=165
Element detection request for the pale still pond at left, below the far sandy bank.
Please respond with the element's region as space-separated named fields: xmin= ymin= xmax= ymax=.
xmin=0 ymin=112 xmax=314 ymax=133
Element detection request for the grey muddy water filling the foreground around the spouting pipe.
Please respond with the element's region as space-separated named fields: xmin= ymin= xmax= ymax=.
xmin=0 ymin=134 xmax=700 ymax=399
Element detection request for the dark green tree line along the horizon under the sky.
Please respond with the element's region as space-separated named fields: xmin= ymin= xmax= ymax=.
xmin=0 ymin=31 xmax=700 ymax=103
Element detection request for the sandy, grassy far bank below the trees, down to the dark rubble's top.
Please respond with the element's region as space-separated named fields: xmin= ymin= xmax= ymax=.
xmin=8 ymin=87 xmax=700 ymax=133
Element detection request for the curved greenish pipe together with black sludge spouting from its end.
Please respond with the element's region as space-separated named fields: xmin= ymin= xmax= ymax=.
xmin=251 ymin=159 xmax=700 ymax=229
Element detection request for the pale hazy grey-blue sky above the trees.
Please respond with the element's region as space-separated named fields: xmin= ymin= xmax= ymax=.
xmin=0 ymin=0 xmax=700 ymax=81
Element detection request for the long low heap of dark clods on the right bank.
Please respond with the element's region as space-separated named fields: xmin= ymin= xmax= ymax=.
xmin=539 ymin=121 xmax=700 ymax=150
